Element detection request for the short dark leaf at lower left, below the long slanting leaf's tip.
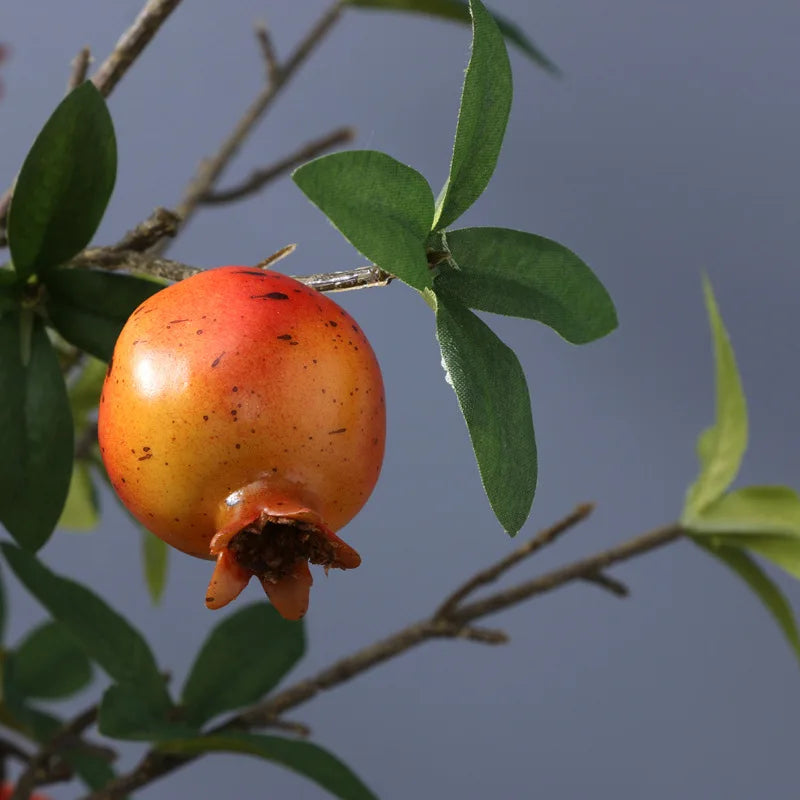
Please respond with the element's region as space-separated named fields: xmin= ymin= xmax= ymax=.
xmin=98 ymin=676 xmax=196 ymax=741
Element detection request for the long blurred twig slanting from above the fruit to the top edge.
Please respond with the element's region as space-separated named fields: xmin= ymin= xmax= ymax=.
xmin=155 ymin=0 xmax=343 ymax=252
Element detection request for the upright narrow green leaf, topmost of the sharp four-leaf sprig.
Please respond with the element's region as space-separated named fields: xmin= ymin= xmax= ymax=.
xmin=433 ymin=0 xmax=513 ymax=230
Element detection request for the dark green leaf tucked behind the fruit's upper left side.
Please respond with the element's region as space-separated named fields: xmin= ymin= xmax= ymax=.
xmin=45 ymin=269 xmax=164 ymax=361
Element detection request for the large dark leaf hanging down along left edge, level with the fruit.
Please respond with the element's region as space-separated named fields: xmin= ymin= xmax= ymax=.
xmin=0 ymin=311 xmax=74 ymax=550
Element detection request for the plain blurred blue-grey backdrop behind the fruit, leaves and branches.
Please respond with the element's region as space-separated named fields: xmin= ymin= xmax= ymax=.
xmin=0 ymin=0 xmax=800 ymax=800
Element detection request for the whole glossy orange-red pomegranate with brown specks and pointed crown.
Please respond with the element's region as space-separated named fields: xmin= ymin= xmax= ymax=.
xmin=98 ymin=267 xmax=386 ymax=619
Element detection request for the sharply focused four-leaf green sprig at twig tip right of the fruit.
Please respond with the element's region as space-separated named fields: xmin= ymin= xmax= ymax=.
xmin=293 ymin=0 xmax=617 ymax=536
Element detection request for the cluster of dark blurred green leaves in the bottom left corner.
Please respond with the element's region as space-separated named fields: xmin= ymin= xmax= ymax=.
xmin=0 ymin=544 xmax=374 ymax=800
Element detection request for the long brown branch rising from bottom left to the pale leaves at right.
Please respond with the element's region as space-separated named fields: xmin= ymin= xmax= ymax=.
xmin=79 ymin=512 xmax=683 ymax=800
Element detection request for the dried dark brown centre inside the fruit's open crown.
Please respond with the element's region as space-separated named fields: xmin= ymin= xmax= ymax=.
xmin=228 ymin=519 xmax=337 ymax=581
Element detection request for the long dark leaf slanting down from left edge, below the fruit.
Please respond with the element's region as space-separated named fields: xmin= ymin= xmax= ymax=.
xmin=0 ymin=544 xmax=169 ymax=706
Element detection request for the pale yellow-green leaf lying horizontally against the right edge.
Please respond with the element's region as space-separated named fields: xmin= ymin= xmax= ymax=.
xmin=690 ymin=486 xmax=800 ymax=537
